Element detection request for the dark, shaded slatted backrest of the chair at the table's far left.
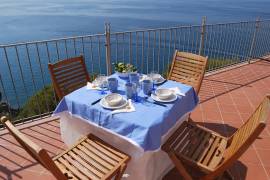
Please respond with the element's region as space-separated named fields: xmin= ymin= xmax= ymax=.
xmin=48 ymin=56 xmax=90 ymax=99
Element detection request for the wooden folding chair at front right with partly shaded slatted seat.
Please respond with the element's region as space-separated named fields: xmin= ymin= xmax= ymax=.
xmin=162 ymin=95 xmax=270 ymax=180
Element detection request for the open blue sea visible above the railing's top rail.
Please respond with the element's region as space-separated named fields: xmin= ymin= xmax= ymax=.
xmin=0 ymin=0 xmax=270 ymax=44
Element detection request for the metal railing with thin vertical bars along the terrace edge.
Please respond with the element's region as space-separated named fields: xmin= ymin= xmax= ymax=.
xmin=0 ymin=18 xmax=270 ymax=124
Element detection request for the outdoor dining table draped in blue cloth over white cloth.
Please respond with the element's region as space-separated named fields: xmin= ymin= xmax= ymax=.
xmin=54 ymin=74 xmax=198 ymax=180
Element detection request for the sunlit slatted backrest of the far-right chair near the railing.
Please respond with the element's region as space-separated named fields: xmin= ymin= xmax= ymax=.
xmin=168 ymin=50 xmax=208 ymax=93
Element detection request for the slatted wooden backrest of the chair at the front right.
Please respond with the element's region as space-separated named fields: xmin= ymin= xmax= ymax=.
xmin=212 ymin=94 xmax=270 ymax=177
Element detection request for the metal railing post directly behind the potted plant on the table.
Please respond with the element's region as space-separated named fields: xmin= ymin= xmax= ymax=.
xmin=105 ymin=23 xmax=112 ymax=75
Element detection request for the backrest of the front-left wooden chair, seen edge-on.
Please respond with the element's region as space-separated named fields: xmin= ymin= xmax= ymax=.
xmin=1 ymin=117 xmax=67 ymax=179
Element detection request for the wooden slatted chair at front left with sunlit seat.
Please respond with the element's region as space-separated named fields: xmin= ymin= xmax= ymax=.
xmin=1 ymin=117 xmax=130 ymax=180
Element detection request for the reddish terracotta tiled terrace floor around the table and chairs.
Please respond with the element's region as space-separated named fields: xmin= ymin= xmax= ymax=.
xmin=0 ymin=61 xmax=270 ymax=180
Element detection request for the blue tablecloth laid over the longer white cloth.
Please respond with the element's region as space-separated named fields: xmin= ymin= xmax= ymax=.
xmin=54 ymin=75 xmax=198 ymax=151
